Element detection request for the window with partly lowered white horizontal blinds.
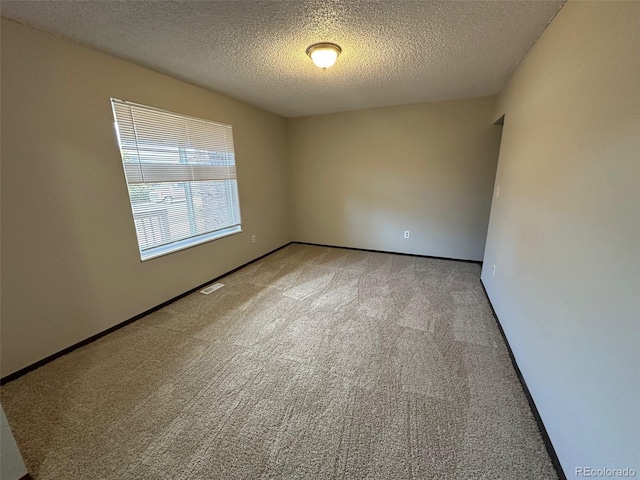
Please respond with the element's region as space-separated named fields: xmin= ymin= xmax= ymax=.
xmin=111 ymin=99 xmax=242 ymax=260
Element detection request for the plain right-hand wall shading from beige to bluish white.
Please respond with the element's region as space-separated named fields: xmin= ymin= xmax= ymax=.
xmin=482 ymin=1 xmax=640 ymax=478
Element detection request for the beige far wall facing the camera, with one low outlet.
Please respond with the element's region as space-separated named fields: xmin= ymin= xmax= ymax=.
xmin=288 ymin=97 xmax=500 ymax=260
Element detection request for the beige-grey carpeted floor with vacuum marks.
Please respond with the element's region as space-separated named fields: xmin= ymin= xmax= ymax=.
xmin=0 ymin=244 xmax=557 ymax=480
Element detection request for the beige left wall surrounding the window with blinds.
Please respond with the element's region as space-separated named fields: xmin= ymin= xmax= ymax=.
xmin=1 ymin=19 xmax=290 ymax=376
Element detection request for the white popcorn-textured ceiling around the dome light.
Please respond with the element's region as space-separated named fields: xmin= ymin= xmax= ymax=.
xmin=0 ymin=0 xmax=564 ymax=117
